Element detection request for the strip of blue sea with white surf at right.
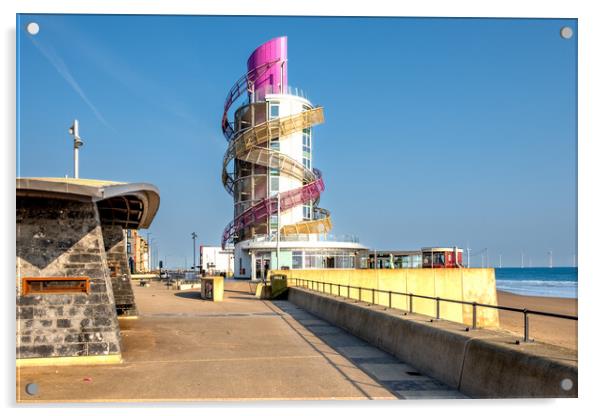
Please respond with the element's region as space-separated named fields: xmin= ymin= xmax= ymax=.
xmin=495 ymin=267 xmax=577 ymax=298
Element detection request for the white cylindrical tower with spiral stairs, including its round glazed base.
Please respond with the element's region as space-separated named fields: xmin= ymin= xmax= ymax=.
xmin=222 ymin=37 xmax=365 ymax=279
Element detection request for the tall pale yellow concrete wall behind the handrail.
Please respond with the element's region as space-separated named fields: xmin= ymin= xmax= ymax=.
xmin=272 ymin=269 xmax=499 ymax=328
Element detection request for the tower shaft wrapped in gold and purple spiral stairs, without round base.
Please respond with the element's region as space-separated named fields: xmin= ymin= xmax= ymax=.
xmin=221 ymin=37 xmax=360 ymax=280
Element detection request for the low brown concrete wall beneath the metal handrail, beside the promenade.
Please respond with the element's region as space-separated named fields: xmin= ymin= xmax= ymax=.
xmin=288 ymin=287 xmax=578 ymax=398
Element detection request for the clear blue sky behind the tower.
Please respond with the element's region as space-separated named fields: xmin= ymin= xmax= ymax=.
xmin=17 ymin=15 xmax=577 ymax=266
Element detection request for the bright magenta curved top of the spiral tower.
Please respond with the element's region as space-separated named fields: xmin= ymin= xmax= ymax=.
xmin=247 ymin=36 xmax=288 ymax=100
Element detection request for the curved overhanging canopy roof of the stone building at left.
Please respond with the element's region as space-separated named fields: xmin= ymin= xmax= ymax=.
xmin=17 ymin=178 xmax=160 ymax=228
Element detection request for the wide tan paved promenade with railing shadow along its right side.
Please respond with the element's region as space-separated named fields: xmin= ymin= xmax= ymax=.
xmin=17 ymin=282 xmax=463 ymax=402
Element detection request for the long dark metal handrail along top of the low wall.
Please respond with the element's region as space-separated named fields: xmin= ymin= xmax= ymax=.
xmin=289 ymin=277 xmax=578 ymax=342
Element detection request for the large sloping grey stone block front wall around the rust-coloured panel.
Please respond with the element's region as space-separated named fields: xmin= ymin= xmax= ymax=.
xmin=16 ymin=196 xmax=121 ymax=358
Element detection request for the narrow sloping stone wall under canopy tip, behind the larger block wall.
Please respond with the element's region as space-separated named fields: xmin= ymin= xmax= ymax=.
xmin=102 ymin=225 xmax=138 ymax=316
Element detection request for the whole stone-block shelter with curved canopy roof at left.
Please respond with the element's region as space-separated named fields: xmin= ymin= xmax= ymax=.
xmin=16 ymin=178 xmax=160 ymax=365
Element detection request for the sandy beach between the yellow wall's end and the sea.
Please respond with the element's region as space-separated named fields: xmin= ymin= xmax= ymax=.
xmin=497 ymin=290 xmax=578 ymax=350
